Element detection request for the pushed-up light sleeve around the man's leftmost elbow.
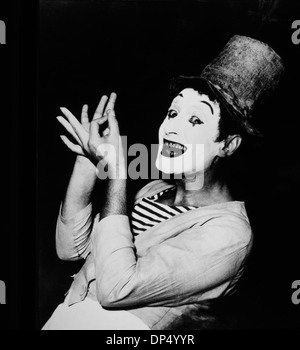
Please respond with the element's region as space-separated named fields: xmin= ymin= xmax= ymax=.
xmin=56 ymin=204 xmax=94 ymax=260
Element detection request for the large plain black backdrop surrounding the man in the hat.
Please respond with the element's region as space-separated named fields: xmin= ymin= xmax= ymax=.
xmin=4 ymin=0 xmax=300 ymax=329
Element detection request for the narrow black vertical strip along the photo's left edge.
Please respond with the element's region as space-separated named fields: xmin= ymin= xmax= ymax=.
xmin=0 ymin=0 xmax=38 ymax=330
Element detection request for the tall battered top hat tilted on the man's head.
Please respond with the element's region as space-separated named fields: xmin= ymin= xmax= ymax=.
xmin=171 ymin=35 xmax=284 ymax=135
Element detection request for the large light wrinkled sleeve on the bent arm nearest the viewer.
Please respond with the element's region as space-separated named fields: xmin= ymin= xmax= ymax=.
xmin=93 ymin=215 xmax=251 ymax=308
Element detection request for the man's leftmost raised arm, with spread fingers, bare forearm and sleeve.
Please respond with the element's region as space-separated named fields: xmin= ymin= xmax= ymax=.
xmin=56 ymin=96 xmax=112 ymax=260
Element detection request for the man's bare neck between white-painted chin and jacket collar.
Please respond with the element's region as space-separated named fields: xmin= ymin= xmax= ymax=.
xmin=174 ymin=173 xmax=233 ymax=207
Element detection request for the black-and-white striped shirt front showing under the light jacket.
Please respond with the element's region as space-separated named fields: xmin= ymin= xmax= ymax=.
xmin=131 ymin=187 xmax=196 ymax=235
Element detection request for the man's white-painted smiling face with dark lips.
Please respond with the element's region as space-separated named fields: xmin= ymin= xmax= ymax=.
xmin=156 ymin=88 xmax=220 ymax=175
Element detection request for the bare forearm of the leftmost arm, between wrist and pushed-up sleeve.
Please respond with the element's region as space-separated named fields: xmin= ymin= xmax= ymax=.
xmin=61 ymin=156 xmax=97 ymax=218
